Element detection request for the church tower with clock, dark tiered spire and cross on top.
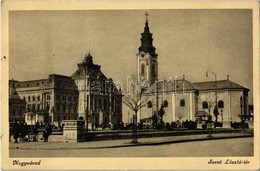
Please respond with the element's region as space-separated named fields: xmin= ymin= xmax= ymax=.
xmin=137 ymin=12 xmax=158 ymax=84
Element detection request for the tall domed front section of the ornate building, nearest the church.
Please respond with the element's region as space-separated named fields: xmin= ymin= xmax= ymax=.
xmin=71 ymin=53 xmax=122 ymax=128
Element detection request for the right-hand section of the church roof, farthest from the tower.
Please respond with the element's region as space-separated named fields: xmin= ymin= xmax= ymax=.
xmin=193 ymin=80 xmax=249 ymax=91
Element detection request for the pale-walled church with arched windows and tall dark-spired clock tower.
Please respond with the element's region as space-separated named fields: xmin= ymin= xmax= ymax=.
xmin=132 ymin=14 xmax=250 ymax=125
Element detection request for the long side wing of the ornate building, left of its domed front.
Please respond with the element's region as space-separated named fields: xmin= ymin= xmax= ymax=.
xmin=11 ymin=74 xmax=78 ymax=125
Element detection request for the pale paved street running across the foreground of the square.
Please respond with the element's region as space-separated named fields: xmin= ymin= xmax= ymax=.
xmin=10 ymin=136 xmax=253 ymax=157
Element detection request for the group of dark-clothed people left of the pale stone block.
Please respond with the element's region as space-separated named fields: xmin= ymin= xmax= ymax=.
xmin=10 ymin=121 xmax=52 ymax=143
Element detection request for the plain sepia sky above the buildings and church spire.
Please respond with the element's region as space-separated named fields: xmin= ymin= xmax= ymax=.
xmin=9 ymin=9 xmax=253 ymax=103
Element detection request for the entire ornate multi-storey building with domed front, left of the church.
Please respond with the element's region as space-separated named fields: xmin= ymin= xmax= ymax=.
xmin=9 ymin=54 xmax=122 ymax=129
